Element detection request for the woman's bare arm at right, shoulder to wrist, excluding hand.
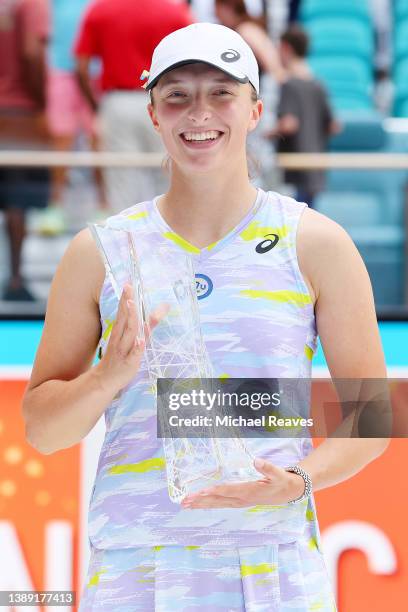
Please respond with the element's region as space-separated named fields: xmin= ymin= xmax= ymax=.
xmin=294 ymin=209 xmax=389 ymax=491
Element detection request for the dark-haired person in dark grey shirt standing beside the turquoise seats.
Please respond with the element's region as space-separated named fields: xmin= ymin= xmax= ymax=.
xmin=268 ymin=26 xmax=340 ymax=206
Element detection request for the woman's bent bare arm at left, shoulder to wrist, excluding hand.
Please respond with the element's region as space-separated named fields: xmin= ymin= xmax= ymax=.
xmin=23 ymin=230 xmax=111 ymax=454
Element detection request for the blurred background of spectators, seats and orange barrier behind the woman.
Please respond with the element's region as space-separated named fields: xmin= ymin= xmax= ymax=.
xmin=0 ymin=0 xmax=408 ymax=612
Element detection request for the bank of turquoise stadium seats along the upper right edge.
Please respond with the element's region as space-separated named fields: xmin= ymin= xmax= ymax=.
xmin=292 ymin=0 xmax=408 ymax=306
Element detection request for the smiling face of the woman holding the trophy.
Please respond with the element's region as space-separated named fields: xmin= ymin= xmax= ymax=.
xmin=148 ymin=63 xmax=262 ymax=173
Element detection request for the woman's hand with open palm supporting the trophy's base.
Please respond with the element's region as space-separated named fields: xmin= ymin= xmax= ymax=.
xmin=181 ymin=459 xmax=305 ymax=510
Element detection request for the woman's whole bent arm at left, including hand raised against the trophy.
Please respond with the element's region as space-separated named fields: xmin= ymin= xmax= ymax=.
xmin=23 ymin=229 xmax=159 ymax=454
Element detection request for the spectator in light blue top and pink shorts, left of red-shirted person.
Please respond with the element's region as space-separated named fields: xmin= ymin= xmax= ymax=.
xmin=38 ymin=0 xmax=108 ymax=234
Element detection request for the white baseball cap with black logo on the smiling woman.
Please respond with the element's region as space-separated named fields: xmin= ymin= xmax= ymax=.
xmin=140 ymin=23 xmax=259 ymax=95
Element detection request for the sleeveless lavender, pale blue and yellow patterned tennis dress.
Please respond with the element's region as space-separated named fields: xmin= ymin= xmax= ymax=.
xmin=79 ymin=189 xmax=336 ymax=612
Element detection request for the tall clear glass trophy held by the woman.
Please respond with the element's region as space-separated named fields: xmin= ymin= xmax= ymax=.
xmin=89 ymin=224 xmax=261 ymax=503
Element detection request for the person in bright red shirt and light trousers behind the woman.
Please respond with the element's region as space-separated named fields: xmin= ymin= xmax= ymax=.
xmin=75 ymin=0 xmax=193 ymax=211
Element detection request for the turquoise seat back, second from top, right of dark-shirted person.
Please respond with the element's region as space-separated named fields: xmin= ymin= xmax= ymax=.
xmin=305 ymin=17 xmax=374 ymax=64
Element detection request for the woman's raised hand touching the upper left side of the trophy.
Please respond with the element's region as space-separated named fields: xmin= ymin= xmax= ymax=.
xmin=95 ymin=284 xmax=169 ymax=392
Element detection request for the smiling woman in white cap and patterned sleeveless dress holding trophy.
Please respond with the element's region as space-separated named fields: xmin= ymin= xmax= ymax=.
xmin=24 ymin=24 xmax=387 ymax=612
